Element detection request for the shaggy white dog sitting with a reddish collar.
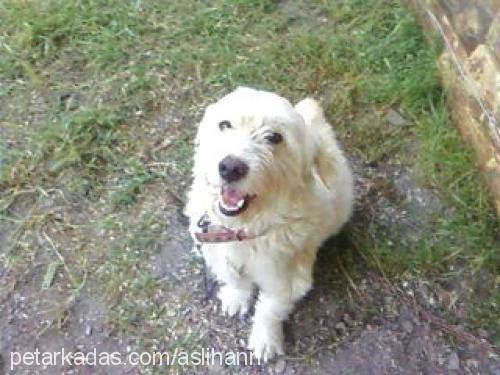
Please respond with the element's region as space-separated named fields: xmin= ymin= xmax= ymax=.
xmin=185 ymin=88 xmax=353 ymax=360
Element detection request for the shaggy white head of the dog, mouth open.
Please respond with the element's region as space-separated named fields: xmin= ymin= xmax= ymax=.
xmin=195 ymin=88 xmax=313 ymax=217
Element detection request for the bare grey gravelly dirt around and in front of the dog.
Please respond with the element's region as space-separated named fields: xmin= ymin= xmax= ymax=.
xmin=0 ymin=149 xmax=500 ymax=374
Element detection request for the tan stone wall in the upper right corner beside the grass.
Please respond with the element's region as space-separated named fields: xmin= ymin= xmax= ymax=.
xmin=410 ymin=0 xmax=500 ymax=215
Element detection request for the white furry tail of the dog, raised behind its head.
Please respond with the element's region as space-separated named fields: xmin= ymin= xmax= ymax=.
xmin=295 ymin=98 xmax=350 ymax=189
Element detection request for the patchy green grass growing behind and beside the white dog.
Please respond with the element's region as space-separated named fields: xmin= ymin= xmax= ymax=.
xmin=0 ymin=0 xmax=500 ymax=364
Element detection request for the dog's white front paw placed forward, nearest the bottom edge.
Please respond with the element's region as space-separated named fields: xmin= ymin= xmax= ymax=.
xmin=248 ymin=324 xmax=285 ymax=362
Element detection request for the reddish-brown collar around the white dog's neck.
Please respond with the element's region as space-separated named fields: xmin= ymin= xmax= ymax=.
xmin=194 ymin=213 xmax=258 ymax=244
